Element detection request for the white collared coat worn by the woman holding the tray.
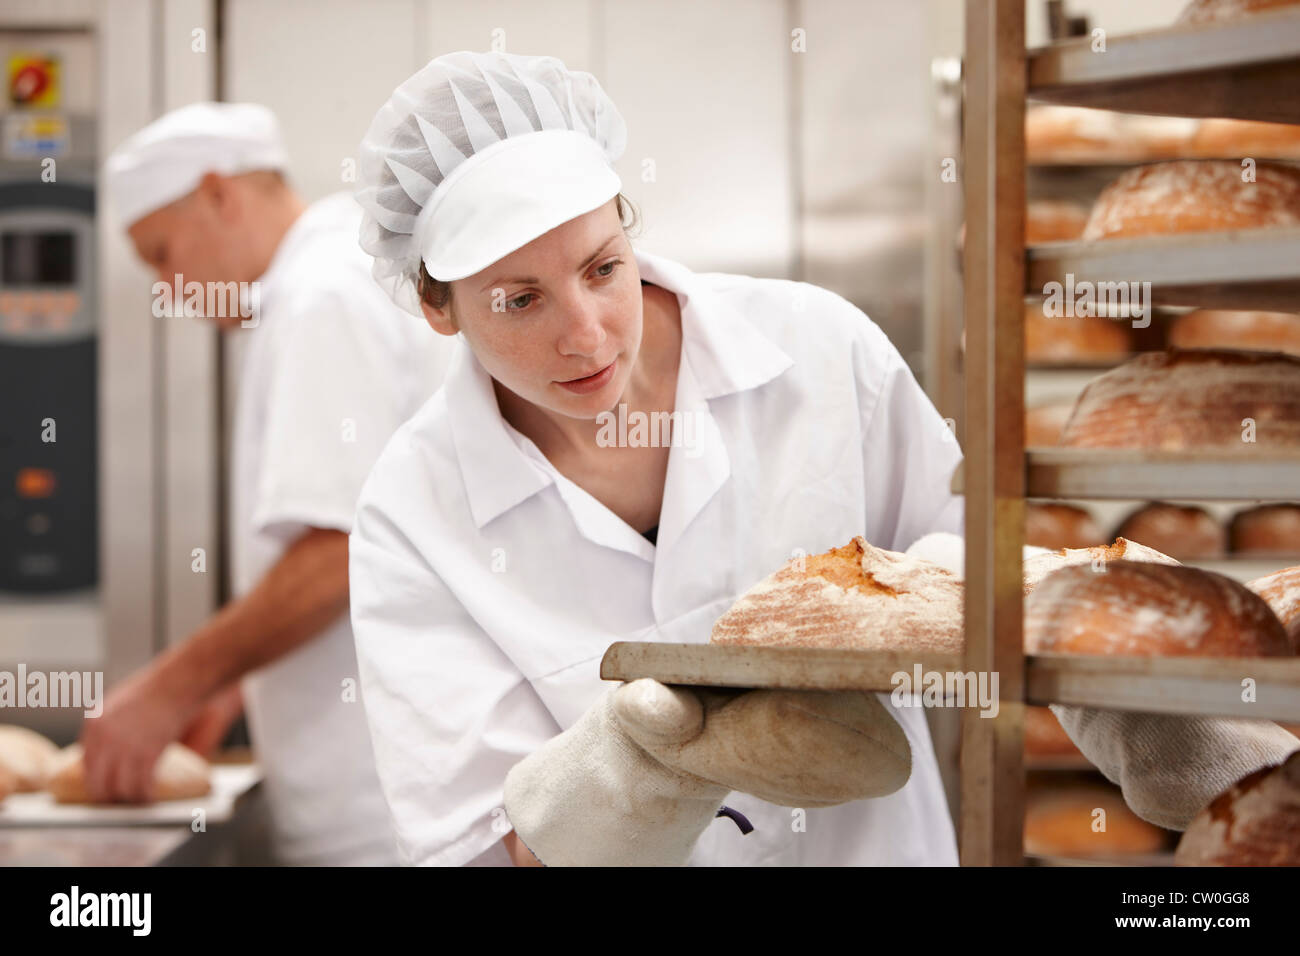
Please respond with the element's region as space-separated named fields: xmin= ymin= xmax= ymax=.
xmin=351 ymin=252 xmax=963 ymax=865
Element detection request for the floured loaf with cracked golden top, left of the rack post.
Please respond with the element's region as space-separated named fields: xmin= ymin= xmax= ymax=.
xmin=711 ymin=536 xmax=963 ymax=652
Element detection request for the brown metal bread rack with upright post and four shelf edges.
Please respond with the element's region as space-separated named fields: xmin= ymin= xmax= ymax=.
xmin=956 ymin=0 xmax=1300 ymax=866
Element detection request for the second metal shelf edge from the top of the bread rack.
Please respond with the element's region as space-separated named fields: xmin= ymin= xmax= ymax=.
xmin=1024 ymin=227 xmax=1300 ymax=311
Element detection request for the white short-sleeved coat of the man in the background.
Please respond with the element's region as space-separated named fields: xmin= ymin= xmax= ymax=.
xmin=231 ymin=194 xmax=451 ymax=865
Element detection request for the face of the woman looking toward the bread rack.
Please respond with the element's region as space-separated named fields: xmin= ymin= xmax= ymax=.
xmin=424 ymin=199 xmax=642 ymax=419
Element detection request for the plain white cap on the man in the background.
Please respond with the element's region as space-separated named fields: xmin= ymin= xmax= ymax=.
xmin=104 ymin=103 xmax=289 ymax=229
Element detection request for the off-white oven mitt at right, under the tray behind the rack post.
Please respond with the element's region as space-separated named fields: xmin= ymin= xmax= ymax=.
xmin=1050 ymin=704 xmax=1300 ymax=830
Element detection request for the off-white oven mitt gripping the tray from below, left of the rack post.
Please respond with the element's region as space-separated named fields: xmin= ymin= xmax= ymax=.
xmin=506 ymin=679 xmax=911 ymax=866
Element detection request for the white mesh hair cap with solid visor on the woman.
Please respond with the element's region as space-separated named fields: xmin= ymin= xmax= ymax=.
xmin=356 ymin=52 xmax=627 ymax=315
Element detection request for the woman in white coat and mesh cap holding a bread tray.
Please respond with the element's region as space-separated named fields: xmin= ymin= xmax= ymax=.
xmin=351 ymin=52 xmax=962 ymax=865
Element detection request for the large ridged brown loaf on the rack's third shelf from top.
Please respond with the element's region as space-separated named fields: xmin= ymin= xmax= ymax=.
xmin=1061 ymin=350 xmax=1300 ymax=453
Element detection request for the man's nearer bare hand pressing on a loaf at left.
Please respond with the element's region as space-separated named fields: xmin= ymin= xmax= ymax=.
xmin=81 ymin=665 xmax=199 ymax=804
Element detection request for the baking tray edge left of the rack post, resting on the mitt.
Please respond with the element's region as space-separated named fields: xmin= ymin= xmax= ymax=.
xmin=601 ymin=641 xmax=962 ymax=692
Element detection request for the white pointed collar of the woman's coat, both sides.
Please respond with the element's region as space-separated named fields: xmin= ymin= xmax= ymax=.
xmin=445 ymin=250 xmax=794 ymax=530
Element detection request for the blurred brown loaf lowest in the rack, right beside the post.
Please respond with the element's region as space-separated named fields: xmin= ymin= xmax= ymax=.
xmin=1024 ymin=782 xmax=1169 ymax=860
